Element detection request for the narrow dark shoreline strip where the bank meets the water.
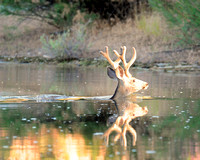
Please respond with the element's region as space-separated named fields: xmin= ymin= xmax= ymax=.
xmin=0 ymin=56 xmax=200 ymax=73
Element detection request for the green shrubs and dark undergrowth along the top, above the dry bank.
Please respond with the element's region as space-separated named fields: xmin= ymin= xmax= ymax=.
xmin=0 ymin=0 xmax=148 ymax=28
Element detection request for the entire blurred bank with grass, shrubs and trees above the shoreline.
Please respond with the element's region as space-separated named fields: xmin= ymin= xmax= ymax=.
xmin=0 ymin=0 xmax=200 ymax=65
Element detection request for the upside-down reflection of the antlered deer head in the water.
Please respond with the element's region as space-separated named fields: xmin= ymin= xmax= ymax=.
xmin=104 ymin=99 xmax=148 ymax=147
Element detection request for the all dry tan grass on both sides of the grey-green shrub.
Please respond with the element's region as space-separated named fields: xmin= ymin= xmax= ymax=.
xmin=0 ymin=13 xmax=200 ymax=63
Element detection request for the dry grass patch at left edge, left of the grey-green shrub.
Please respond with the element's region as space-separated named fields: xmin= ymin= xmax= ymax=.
xmin=0 ymin=16 xmax=55 ymax=56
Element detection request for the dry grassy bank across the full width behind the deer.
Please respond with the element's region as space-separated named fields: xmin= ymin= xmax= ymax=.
xmin=0 ymin=9 xmax=200 ymax=66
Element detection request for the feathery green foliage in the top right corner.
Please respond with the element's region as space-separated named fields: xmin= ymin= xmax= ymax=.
xmin=149 ymin=0 xmax=200 ymax=45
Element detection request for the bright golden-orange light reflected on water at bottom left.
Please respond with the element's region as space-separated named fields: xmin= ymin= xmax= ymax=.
xmin=3 ymin=125 xmax=106 ymax=160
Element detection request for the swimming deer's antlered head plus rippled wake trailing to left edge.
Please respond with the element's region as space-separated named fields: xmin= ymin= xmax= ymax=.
xmin=0 ymin=46 xmax=149 ymax=102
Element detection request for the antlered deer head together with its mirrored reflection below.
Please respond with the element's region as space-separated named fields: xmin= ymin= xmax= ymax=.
xmin=100 ymin=46 xmax=148 ymax=147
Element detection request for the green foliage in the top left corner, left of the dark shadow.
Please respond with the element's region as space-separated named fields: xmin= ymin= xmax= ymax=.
xmin=0 ymin=0 xmax=78 ymax=28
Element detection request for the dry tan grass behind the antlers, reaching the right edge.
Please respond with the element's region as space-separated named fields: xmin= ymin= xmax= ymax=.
xmin=86 ymin=13 xmax=200 ymax=64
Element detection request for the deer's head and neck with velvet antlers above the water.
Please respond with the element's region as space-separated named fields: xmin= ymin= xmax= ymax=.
xmin=100 ymin=46 xmax=148 ymax=99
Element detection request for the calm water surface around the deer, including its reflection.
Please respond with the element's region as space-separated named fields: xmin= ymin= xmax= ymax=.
xmin=0 ymin=63 xmax=200 ymax=160
